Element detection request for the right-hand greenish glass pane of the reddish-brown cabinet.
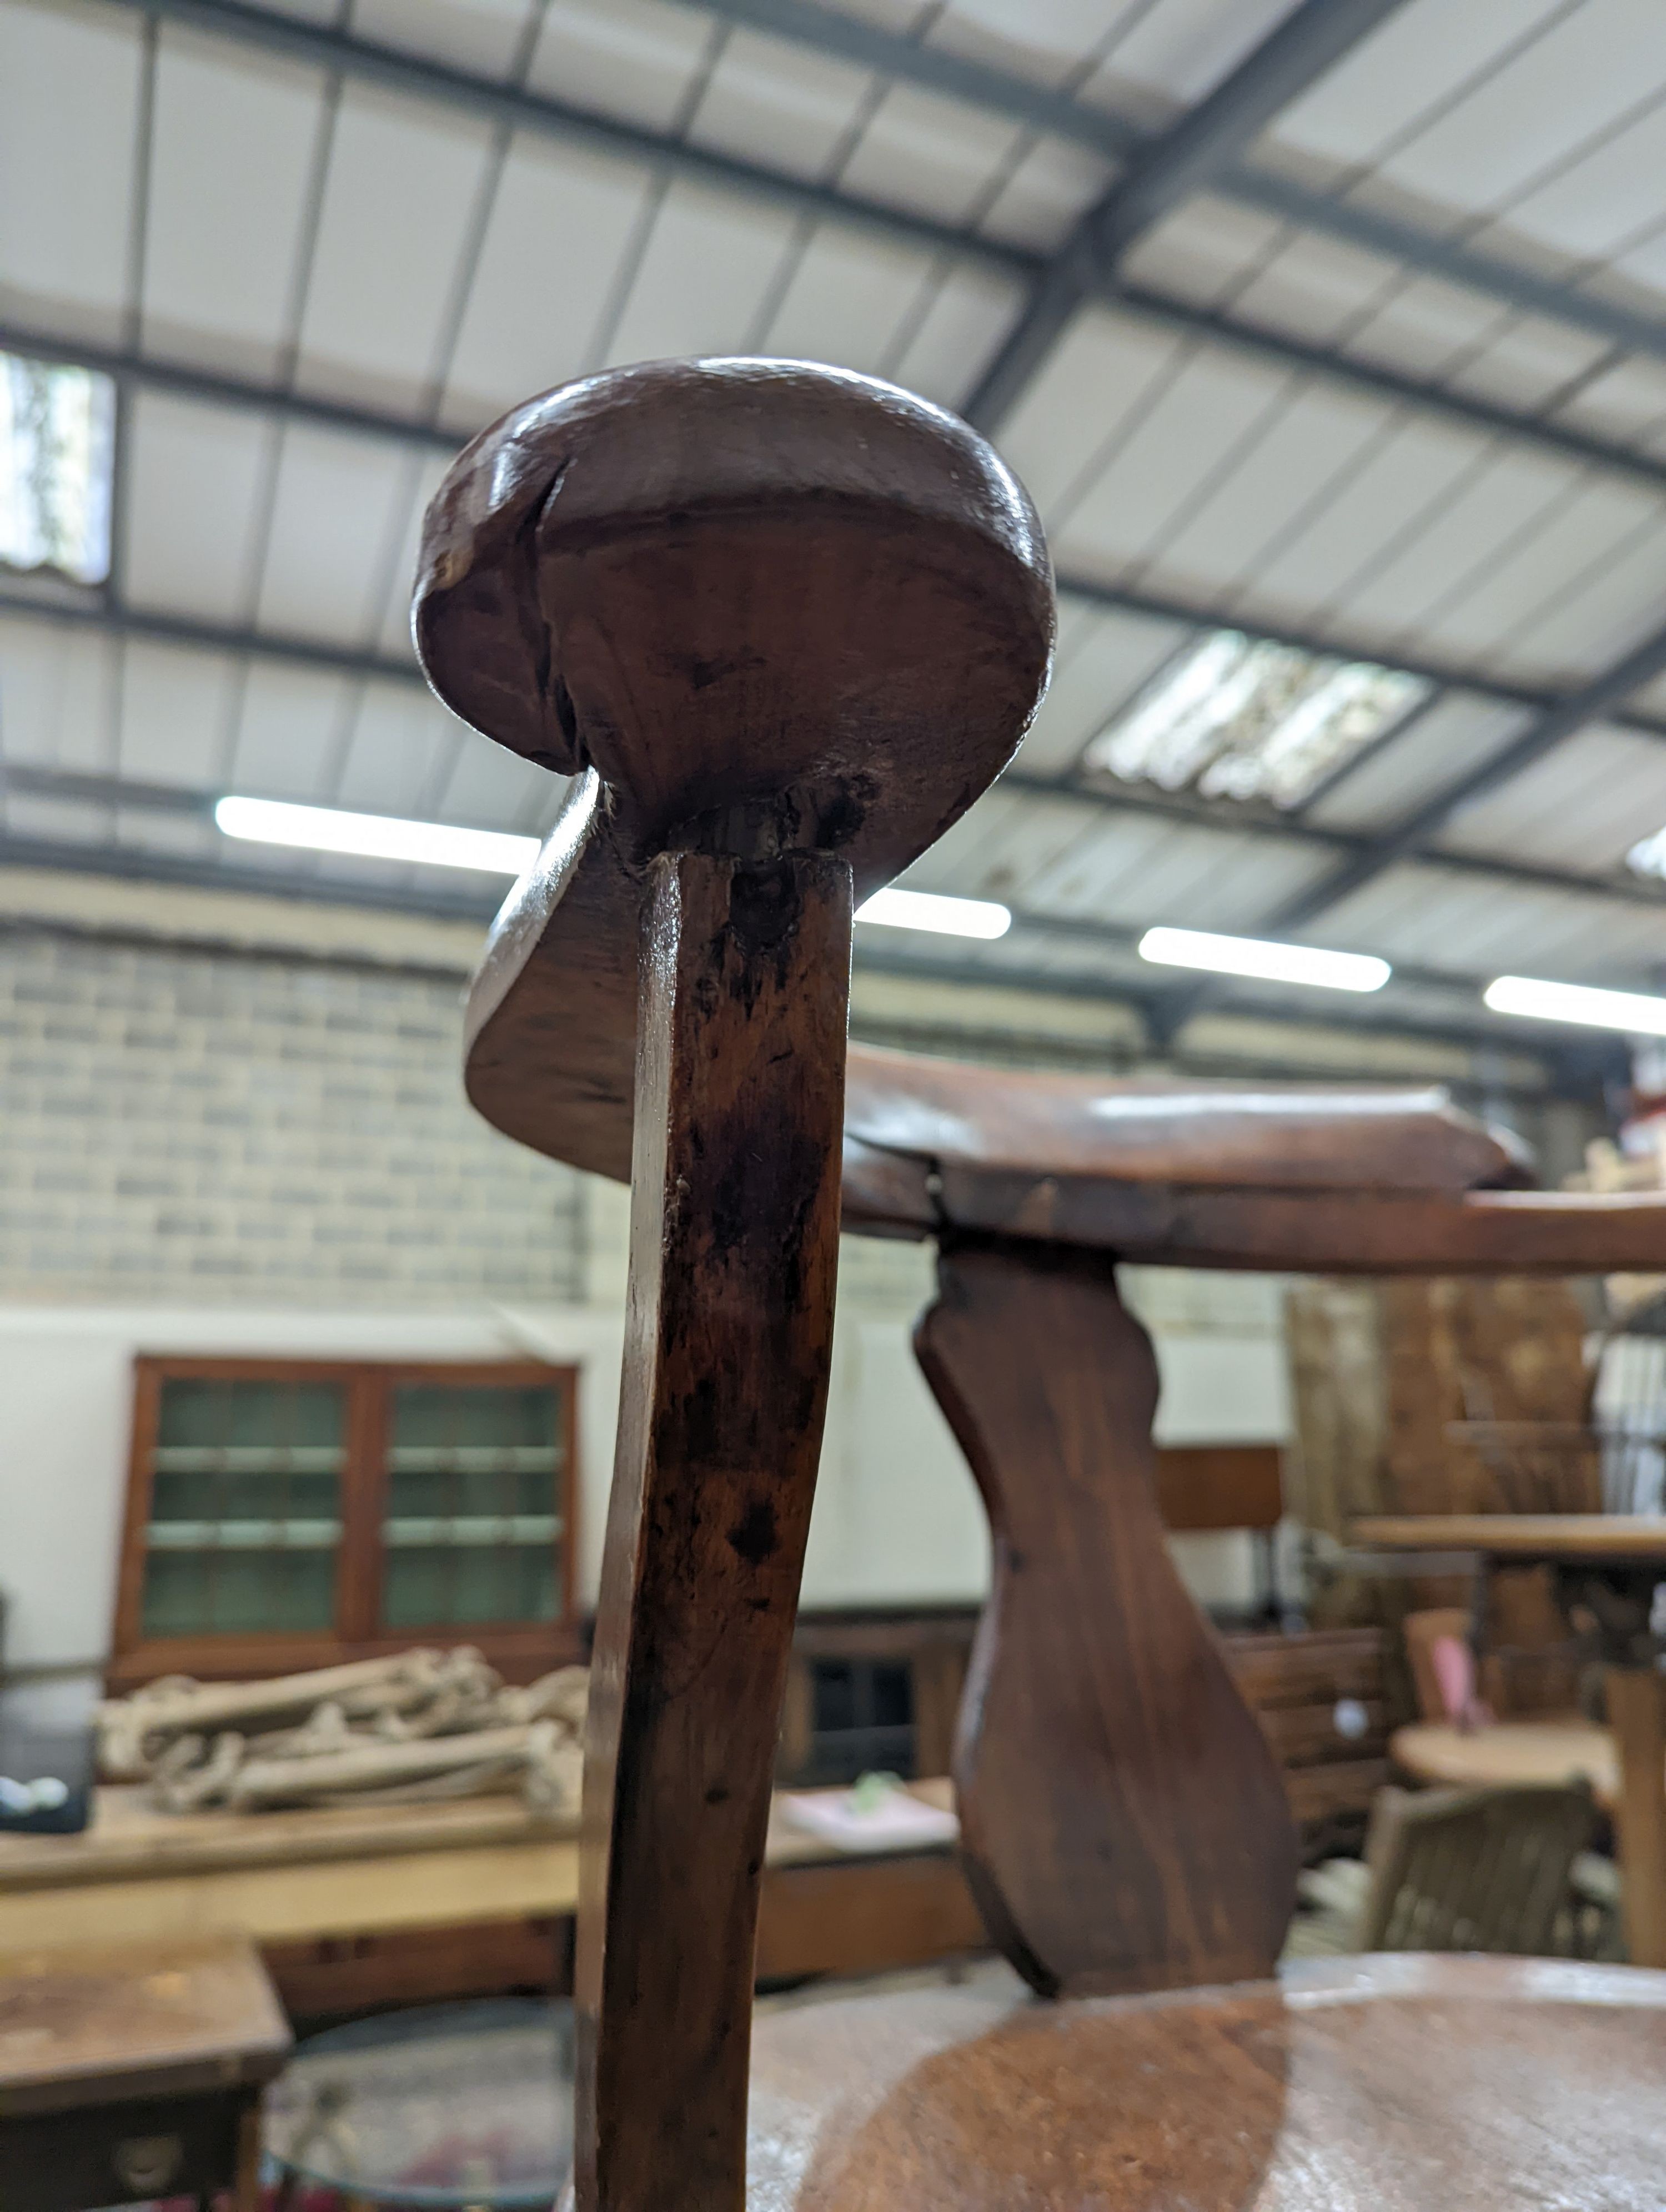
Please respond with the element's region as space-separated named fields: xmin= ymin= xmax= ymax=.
xmin=383 ymin=1382 xmax=566 ymax=1630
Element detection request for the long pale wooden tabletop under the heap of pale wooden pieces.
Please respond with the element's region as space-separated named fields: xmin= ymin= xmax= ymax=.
xmin=0 ymin=1778 xmax=954 ymax=1893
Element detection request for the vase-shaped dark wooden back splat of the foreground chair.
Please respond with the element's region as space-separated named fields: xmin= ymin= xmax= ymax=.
xmin=914 ymin=1241 xmax=1297 ymax=1995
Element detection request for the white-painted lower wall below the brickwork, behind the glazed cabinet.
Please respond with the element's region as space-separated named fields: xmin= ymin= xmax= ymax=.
xmin=0 ymin=1250 xmax=1288 ymax=1712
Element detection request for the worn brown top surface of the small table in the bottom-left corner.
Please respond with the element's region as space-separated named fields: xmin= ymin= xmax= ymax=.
xmin=0 ymin=1936 xmax=290 ymax=2117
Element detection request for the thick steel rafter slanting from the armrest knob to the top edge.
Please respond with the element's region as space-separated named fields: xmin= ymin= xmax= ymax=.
xmin=962 ymin=0 xmax=1405 ymax=429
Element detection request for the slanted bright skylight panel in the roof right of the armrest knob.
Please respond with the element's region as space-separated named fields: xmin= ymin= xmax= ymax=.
xmin=1082 ymin=630 xmax=1429 ymax=807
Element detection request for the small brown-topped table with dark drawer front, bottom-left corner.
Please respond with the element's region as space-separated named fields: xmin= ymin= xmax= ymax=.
xmin=0 ymin=1936 xmax=290 ymax=2212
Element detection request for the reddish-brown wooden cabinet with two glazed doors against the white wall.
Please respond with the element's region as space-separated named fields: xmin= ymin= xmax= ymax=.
xmin=113 ymin=1360 xmax=578 ymax=1683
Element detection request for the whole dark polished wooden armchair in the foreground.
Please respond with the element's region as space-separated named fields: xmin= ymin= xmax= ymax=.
xmin=416 ymin=363 xmax=1666 ymax=2212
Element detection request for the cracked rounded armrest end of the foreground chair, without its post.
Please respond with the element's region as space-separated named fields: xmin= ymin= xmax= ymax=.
xmin=429 ymin=360 xmax=1053 ymax=1179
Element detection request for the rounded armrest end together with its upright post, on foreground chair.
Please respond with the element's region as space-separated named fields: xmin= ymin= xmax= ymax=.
xmin=414 ymin=360 xmax=1053 ymax=2212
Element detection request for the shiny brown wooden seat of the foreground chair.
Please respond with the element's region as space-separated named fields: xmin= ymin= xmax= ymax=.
xmin=748 ymin=1953 xmax=1666 ymax=2212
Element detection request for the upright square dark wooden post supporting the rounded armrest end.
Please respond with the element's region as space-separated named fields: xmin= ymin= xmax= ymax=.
xmin=575 ymin=854 xmax=852 ymax=2212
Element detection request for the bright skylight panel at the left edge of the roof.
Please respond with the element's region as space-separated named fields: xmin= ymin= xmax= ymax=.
xmin=0 ymin=354 xmax=115 ymax=584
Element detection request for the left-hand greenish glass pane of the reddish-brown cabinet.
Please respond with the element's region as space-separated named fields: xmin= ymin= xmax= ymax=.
xmin=142 ymin=1376 xmax=347 ymax=1637
